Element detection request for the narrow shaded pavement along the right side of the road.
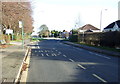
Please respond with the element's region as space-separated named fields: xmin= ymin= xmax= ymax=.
xmin=62 ymin=41 xmax=120 ymax=57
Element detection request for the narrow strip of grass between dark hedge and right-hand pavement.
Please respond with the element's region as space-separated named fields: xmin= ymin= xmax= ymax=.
xmin=73 ymin=42 xmax=120 ymax=52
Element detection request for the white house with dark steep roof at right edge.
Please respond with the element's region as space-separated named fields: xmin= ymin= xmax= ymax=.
xmin=103 ymin=20 xmax=120 ymax=32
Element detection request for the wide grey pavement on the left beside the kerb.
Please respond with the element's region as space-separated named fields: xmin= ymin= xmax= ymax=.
xmin=0 ymin=42 xmax=31 ymax=83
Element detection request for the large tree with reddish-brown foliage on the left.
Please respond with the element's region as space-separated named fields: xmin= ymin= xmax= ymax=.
xmin=2 ymin=2 xmax=33 ymax=33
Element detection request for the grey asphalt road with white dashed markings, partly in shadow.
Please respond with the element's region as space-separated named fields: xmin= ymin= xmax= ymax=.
xmin=27 ymin=40 xmax=119 ymax=82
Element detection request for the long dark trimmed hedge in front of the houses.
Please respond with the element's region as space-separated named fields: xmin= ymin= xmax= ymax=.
xmin=78 ymin=31 xmax=120 ymax=47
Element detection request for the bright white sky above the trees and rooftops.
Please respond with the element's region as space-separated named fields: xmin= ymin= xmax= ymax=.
xmin=32 ymin=0 xmax=119 ymax=32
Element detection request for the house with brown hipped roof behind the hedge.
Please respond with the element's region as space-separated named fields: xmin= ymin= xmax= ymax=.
xmin=78 ymin=24 xmax=100 ymax=32
